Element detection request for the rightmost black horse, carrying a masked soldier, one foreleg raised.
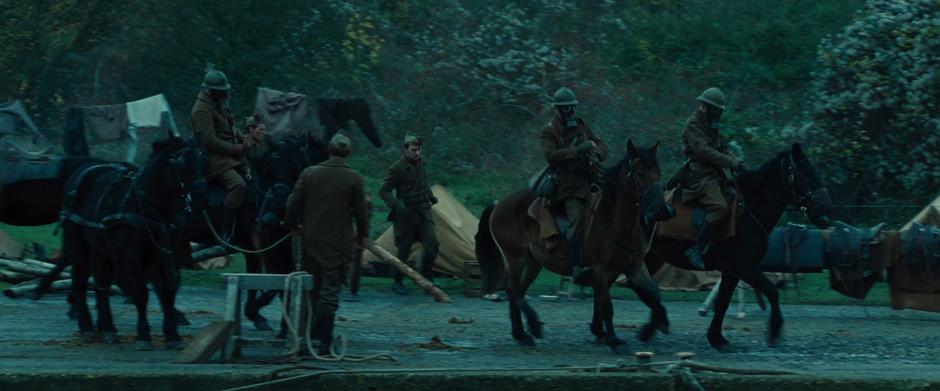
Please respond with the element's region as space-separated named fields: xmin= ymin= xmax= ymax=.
xmin=646 ymin=144 xmax=832 ymax=351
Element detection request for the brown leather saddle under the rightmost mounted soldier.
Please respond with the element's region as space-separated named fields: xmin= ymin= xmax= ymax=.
xmin=656 ymin=189 xmax=739 ymax=243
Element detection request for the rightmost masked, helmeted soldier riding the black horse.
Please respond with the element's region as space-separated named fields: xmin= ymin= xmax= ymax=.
xmin=677 ymin=87 xmax=747 ymax=269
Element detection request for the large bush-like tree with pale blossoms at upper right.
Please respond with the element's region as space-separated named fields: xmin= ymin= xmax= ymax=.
xmin=807 ymin=0 xmax=940 ymax=202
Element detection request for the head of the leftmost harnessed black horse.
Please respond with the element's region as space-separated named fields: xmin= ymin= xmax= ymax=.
xmin=147 ymin=133 xmax=207 ymax=213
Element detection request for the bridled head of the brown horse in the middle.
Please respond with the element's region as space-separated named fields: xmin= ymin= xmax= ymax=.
xmin=608 ymin=140 xmax=675 ymax=224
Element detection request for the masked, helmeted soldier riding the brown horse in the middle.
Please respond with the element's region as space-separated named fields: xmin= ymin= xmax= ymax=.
xmin=540 ymin=87 xmax=607 ymax=284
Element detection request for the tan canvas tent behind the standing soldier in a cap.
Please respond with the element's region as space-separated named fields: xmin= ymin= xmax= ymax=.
xmin=362 ymin=185 xmax=479 ymax=277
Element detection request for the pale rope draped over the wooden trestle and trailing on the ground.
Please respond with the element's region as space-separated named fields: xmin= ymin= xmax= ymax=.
xmin=282 ymin=272 xmax=398 ymax=362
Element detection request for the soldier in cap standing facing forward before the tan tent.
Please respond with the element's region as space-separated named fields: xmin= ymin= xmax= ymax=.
xmin=379 ymin=136 xmax=438 ymax=295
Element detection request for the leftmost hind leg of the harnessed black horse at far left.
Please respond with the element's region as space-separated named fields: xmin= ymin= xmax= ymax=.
xmin=62 ymin=228 xmax=95 ymax=339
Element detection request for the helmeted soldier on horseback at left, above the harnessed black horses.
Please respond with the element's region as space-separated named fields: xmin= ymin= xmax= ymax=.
xmin=191 ymin=69 xmax=251 ymax=240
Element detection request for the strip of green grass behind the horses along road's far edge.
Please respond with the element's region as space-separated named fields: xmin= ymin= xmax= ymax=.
xmin=0 ymin=222 xmax=890 ymax=306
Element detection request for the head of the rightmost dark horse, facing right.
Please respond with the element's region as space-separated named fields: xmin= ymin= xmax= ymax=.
xmin=779 ymin=143 xmax=832 ymax=229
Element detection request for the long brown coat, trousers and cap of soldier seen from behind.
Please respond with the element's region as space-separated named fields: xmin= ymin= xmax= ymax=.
xmin=285 ymin=136 xmax=369 ymax=353
